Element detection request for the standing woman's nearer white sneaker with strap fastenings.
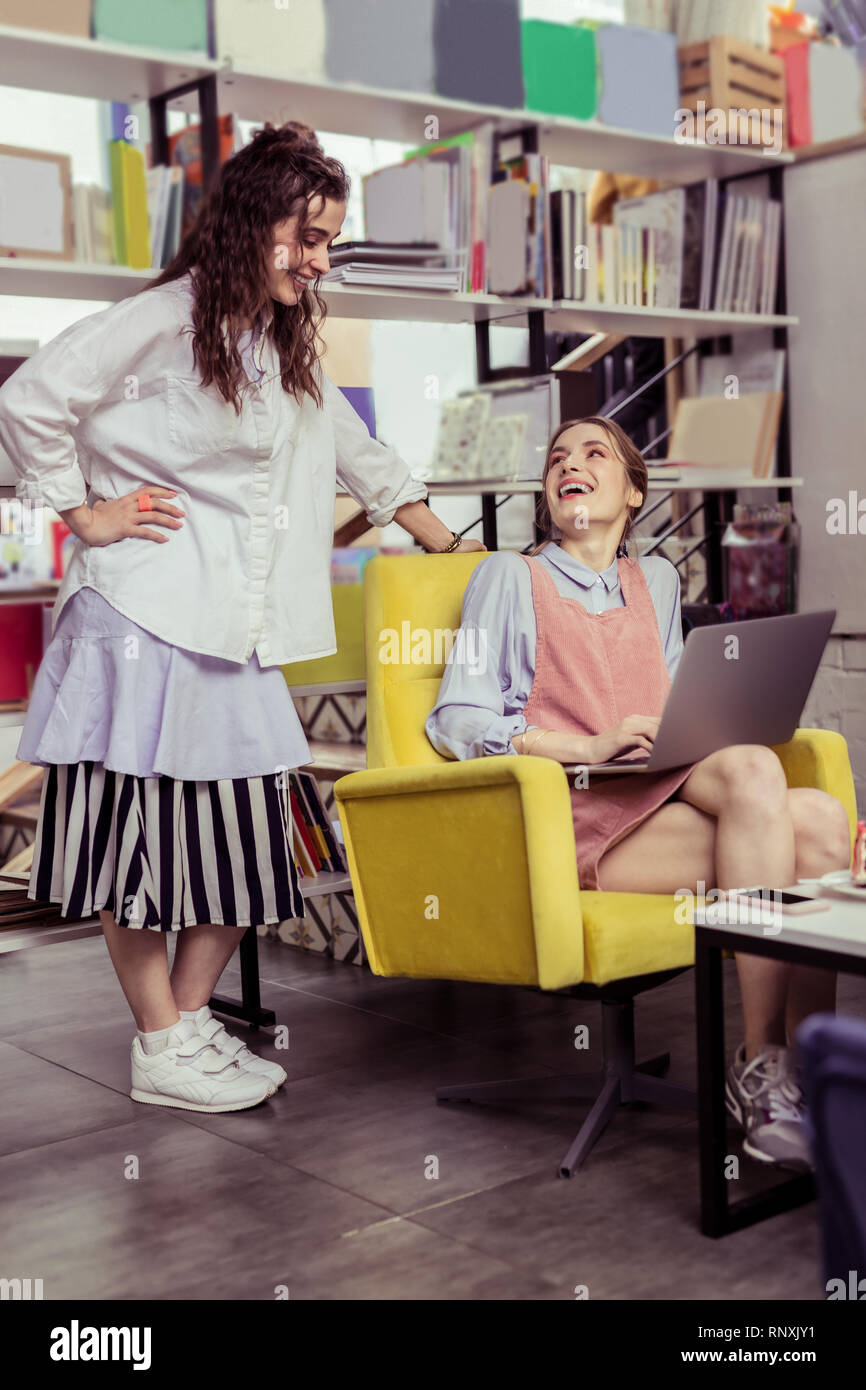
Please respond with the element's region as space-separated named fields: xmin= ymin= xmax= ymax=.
xmin=129 ymin=1019 xmax=277 ymax=1113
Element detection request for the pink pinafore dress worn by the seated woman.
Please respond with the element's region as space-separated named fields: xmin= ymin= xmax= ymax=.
xmin=523 ymin=555 xmax=695 ymax=890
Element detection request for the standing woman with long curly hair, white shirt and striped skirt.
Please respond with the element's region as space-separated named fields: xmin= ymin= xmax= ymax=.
xmin=0 ymin=122 xmax=482 ymax=1111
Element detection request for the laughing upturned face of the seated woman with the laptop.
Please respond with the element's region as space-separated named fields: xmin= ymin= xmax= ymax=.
xmin=545 ymin=424 xmax=642 ymax=539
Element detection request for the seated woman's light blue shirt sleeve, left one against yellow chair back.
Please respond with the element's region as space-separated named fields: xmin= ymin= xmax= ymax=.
xmin=424 ymin=550 xmax=537 ymax=759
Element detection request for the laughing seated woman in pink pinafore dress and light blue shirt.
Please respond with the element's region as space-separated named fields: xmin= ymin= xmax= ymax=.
xmin=425 ymin=417 xmax=851 ymax=1166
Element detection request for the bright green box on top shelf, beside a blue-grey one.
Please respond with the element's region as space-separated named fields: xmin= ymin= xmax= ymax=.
xmin=520 ymin=19 xmax=598 ymax=121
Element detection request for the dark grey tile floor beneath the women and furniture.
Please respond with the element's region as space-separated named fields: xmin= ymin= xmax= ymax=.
xmin=0 ymin=938 xmax=866 ymax=1300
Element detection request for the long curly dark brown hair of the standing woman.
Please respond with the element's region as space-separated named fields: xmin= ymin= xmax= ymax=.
xmin=142 ymin=121 xmax=349 ymax=413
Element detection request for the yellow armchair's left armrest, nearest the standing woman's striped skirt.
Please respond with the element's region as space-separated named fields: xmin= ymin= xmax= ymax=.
xmin=334 ymin=755 xmax=584 ymax=990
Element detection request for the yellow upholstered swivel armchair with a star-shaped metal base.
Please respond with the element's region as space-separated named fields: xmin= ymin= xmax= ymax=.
xmin=334 ymin=552 xmax=856 ymax=1176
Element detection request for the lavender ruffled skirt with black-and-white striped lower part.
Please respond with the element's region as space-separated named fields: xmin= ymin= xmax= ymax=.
xmin=18 ymin=588 xmax=310 ymax=931
